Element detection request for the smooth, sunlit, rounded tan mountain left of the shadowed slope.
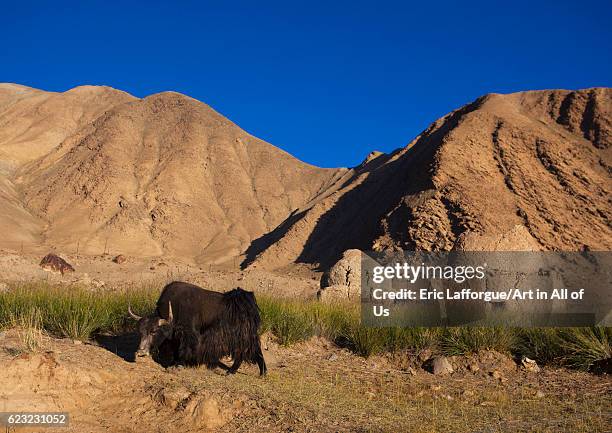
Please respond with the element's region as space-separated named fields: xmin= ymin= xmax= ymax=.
xmin=0 ymin=83 xmax=344 ymax=262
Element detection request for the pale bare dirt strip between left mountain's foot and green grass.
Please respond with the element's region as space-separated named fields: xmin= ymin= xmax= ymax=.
xmin=0 ymin=249 xmax=320 ymax=299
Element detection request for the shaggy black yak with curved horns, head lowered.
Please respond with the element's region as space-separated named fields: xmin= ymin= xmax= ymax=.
xmin=128 ymin=282 xmax=267 ymax=375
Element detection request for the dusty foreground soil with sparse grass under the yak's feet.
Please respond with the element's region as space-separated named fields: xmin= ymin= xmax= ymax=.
xmin=0 ymin=330 xmax=612 ymax=433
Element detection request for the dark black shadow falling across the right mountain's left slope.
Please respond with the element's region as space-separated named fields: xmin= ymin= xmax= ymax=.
xmin=241 ymin=98 xmax=484 ymax=270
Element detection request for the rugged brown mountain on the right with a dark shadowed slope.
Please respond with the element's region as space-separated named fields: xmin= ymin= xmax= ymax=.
xmin=248 ymin=88 xmax=612 ymax=267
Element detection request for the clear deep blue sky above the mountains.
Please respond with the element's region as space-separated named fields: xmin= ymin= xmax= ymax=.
xmin=0 ymin=0 xmax=612 ymax=167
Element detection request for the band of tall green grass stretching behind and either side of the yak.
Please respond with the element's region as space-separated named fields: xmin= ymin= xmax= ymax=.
xmin=0 ymin=283 xmax=612 ymax=370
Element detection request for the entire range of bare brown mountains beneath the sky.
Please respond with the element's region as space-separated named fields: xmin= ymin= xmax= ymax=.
xmin=0 ymin=85 xmax=612 ymax=269
